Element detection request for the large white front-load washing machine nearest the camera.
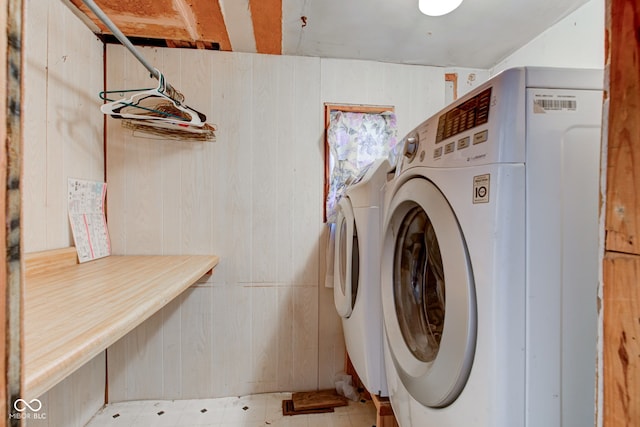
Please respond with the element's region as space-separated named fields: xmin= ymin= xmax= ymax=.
xmin=381 ymin=68 xmax=603 ymax=427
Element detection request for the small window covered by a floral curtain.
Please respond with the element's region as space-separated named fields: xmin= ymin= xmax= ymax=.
xmin=324 ymin=104 xmax=398 ymax=222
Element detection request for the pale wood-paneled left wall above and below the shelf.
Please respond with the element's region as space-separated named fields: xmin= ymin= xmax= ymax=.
xmin=21 ymin=0 xmax=106 ymax=427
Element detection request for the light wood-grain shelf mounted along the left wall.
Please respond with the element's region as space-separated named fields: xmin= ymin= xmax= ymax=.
xmin=23 ymin=248 xmax=218 ymax=400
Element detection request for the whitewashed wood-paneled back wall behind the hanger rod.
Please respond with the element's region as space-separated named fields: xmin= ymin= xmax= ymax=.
xmin=107 ymin=46 xmax=444 ymax=401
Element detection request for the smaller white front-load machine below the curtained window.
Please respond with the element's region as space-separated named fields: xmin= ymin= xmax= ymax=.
xmin=333 ymin=160 xmax=390 ymax=396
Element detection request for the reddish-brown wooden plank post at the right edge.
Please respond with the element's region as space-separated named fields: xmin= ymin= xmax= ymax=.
xmin=601 ymin=0 xmax=640 ymax=427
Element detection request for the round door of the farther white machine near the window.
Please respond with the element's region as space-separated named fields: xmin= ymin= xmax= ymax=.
xmin=333 ymin=197 xmax=360 ymax=318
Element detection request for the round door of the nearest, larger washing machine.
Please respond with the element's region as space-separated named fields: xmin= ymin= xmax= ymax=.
xmin=381 ymin=178 xmax=477 ymax=408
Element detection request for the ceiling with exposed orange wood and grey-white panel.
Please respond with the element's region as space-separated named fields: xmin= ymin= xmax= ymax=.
xmin=65 ymin=0 xmax=588 ymax=69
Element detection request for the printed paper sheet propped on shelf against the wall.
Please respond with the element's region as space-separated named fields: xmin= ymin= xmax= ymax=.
xmin=68 ymin=178 xmax=111 ymax=263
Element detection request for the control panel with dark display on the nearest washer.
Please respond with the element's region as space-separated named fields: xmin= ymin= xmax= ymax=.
xmin=398 ymin=69 xmax=526 ymax=173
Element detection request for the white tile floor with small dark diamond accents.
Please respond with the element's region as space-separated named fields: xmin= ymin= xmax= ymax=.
xmin=86 ymin=393 xmax=376 ymax=427
